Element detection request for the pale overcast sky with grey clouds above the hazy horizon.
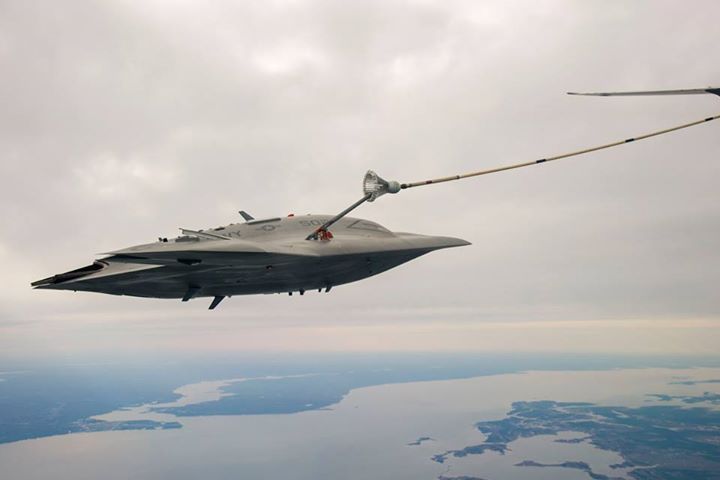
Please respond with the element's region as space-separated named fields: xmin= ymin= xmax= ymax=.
xmin=0 ymin=0 xmax=720 ymax=356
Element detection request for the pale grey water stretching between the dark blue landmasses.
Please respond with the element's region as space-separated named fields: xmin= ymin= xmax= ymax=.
xmin=0 ymin=368 xmax=720 ymax=480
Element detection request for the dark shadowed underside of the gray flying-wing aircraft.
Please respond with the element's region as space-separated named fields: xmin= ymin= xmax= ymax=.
xmin=34 ymin=248 xmax=444 ymax=299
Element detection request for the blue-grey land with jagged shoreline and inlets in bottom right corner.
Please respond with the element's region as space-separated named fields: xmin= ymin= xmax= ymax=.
xmin=432 ymin=400 xmax=720 ymax=480
